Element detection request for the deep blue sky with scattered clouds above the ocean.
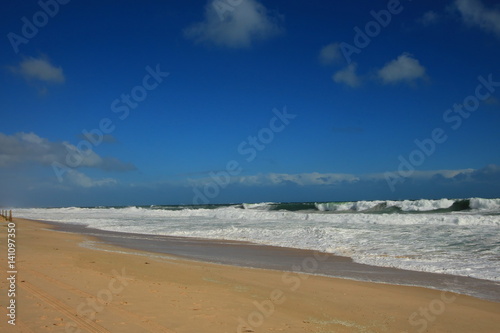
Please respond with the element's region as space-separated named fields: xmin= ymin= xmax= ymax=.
xmin=0 ymin=0 xmax=500 ymax=206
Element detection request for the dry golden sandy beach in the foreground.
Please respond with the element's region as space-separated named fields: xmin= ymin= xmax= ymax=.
xmin=0 ymin=219 xmax=500 ymax=332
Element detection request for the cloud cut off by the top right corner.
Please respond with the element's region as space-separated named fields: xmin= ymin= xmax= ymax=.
xmin=454 ymin=0 xmax=500 ymax=37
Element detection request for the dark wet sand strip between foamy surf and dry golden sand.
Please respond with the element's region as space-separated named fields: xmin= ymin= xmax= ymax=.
xmin=39 ymin=217 xmax=500 ymax=302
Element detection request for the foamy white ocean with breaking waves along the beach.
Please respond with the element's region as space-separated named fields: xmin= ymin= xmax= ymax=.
xmin=15 ymin=198 xmax=500 ymax=282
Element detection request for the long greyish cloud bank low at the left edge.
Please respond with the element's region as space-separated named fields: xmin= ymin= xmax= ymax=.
xmin=0 ymin=132 xmax=136 ymax=171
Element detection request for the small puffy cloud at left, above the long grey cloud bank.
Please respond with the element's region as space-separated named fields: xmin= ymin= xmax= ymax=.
xmin=13 ymin=57 xmax=65 ymax=83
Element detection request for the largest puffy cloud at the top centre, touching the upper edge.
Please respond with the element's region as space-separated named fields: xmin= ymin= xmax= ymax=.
xmin=184 ymin=0 xmax=283 ymax=48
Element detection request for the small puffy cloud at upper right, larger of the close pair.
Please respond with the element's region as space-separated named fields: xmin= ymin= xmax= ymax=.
xmin=377 ymin=53 xmax=426 ymax=84
